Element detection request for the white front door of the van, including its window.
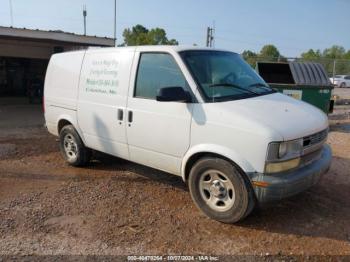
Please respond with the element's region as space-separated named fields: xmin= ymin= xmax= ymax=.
xmin=126 ymin=51 xmax=193 ymax=174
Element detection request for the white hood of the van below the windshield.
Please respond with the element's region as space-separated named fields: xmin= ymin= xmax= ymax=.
xmin=212 ymin=93 xmax=328 ymax=141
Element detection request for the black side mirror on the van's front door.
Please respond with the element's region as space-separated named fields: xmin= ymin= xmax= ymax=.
xmin=157 ymin=87 xmax=192 ymax=103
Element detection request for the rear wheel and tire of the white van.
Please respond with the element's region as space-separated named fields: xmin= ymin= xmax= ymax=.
xmin=60 ymin=125 xmax=91 ymax=167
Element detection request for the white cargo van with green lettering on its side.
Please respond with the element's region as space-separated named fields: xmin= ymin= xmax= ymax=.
xmin=44 ymin=46 xmax=332 ymax=223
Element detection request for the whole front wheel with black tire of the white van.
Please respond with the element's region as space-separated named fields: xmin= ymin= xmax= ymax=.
xmin=188 ymin=157 xmax=255 ymax=223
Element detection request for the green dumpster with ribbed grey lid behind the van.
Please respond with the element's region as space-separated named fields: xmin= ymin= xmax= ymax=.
xmin=256 ymin=62 xmax=334 ymax=114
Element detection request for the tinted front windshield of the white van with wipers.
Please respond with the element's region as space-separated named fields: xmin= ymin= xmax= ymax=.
xmin=180 ymin=50 xmax=275 ymax=102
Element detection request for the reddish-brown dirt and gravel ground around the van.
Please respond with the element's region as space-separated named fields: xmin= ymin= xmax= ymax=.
xmin=0 ymin=89 xmax=350 ymax=256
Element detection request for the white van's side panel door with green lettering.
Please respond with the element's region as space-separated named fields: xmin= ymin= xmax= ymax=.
xmin=78 ymin=49 xmax=134 ymax=159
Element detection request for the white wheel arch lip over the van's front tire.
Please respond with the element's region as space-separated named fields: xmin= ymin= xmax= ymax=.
xmin=181 ymin=144 xmax=256 ymax=181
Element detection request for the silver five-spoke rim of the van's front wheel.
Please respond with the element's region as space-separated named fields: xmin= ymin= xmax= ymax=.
xmin=199 ymin=170 xmax=235 ymax=212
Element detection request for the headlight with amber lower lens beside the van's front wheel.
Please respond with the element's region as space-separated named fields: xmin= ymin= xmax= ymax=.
xmin=265 ymin=139 xmax=303 ymax=173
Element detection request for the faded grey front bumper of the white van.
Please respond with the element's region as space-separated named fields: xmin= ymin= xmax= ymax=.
xmin=249 ymin=145 xmax=332 ymax=203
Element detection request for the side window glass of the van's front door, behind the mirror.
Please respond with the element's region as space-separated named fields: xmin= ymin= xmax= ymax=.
xmin=134 ymin=53 xmax=188 ymax=99
